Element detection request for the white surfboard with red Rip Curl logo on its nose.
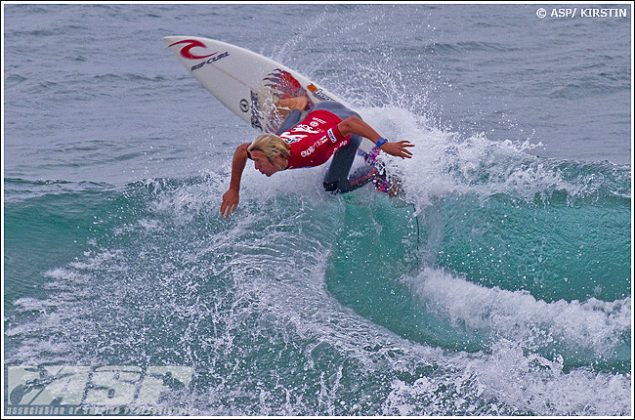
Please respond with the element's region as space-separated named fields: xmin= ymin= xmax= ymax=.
xmin=164 ymin=36 xmax=372 ymax=151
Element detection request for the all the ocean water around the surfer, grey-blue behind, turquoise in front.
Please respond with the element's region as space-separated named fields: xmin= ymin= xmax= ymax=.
xmin=3 ymin=4 xmax=633 ymax=416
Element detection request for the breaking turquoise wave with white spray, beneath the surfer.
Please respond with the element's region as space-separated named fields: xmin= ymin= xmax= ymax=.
xmin=5 ymin=153 xmax=631 ymax=414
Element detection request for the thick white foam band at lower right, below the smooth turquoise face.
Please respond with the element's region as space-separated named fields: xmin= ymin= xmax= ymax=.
xmin=402 ymin=268 xmax=631 ymax=358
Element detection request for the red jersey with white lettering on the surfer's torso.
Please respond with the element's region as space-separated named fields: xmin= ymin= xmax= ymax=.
xmin=280 ymin=109 xmax=351 ymax=169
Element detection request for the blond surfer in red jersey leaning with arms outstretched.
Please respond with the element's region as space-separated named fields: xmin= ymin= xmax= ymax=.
xmin=220 ymin=96 xmax=414 ymax=217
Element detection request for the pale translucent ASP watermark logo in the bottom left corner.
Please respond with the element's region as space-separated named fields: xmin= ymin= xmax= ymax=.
xmin=4 ymin=366 xmax=194 ymax=416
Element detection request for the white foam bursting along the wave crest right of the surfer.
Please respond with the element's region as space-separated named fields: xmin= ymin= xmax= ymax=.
xmin=360 ymin=106 xmax=623 ymax=212
